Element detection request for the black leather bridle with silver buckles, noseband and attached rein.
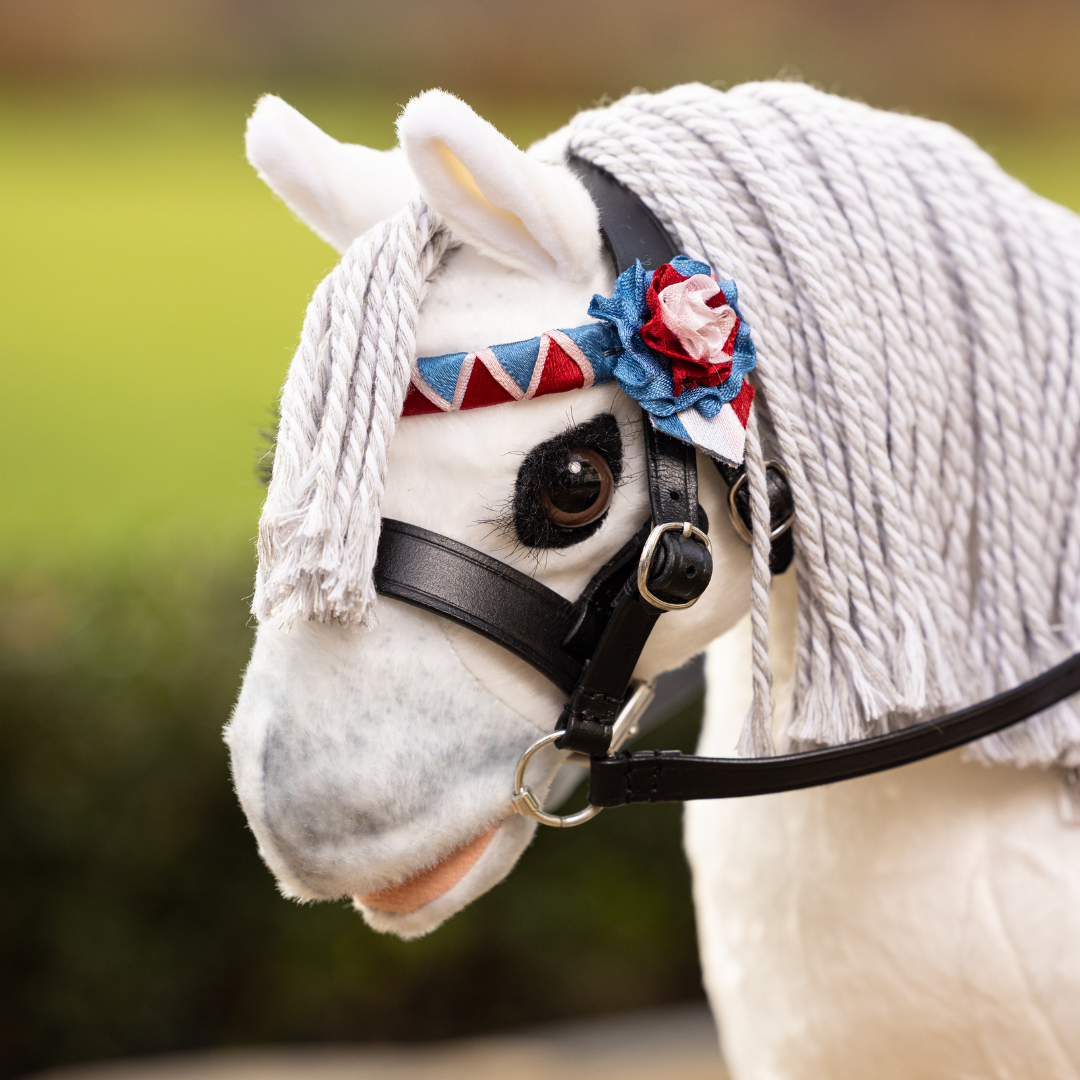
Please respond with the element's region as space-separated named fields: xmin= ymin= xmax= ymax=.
xmin=375 ymin=158 xmax=1080 ymax=823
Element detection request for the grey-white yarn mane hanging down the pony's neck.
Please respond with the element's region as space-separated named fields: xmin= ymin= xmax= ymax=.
xmin=563 ymin=83 xmax=1080 ymax=767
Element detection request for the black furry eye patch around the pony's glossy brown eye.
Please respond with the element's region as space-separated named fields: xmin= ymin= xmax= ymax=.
xmin=513 ymin=413 xmax=622 ymax=548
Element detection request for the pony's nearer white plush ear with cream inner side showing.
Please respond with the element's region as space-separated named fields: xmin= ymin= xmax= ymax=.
xmin=397 ymin=90 xmax=602 ymax=281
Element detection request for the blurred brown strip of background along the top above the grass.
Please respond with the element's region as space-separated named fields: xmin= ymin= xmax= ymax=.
xmin=6 ymin=0 xmax=1080 ymax=116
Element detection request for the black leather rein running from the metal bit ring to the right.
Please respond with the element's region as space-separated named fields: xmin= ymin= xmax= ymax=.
xmin=589 ymin=653 xmax=1080 ymax=807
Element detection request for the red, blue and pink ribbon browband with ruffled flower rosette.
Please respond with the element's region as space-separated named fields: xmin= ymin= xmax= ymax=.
xmin=403 ymin=255 xmax=756 ymax=465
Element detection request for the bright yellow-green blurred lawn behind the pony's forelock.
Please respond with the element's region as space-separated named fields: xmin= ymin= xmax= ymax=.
xmin=0 ymin=90 xmax=583 ymax=564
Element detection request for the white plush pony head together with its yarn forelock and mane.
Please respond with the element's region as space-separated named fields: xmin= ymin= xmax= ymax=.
xmin=228 ymin=83 xmax=1080 ymax=936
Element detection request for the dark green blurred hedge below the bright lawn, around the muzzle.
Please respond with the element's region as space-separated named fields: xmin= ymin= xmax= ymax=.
xmin=0 ymin=555 xmax=701 ymax=1077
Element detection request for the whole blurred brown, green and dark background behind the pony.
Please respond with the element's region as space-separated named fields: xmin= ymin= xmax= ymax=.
xmin=0 ymin=0 xmax=1080 ymax=1077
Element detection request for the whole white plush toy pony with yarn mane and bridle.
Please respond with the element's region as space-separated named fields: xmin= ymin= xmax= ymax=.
xmin=227 ymin=83 xmax=1080 ymax=1080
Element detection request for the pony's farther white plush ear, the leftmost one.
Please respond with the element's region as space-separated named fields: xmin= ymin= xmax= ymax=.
xmin=246 ymin=94 xmax=417 ymax=252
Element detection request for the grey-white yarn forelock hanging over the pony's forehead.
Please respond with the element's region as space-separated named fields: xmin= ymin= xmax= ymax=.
xmin=253 ymin=200 xmax=448 ymax=626
